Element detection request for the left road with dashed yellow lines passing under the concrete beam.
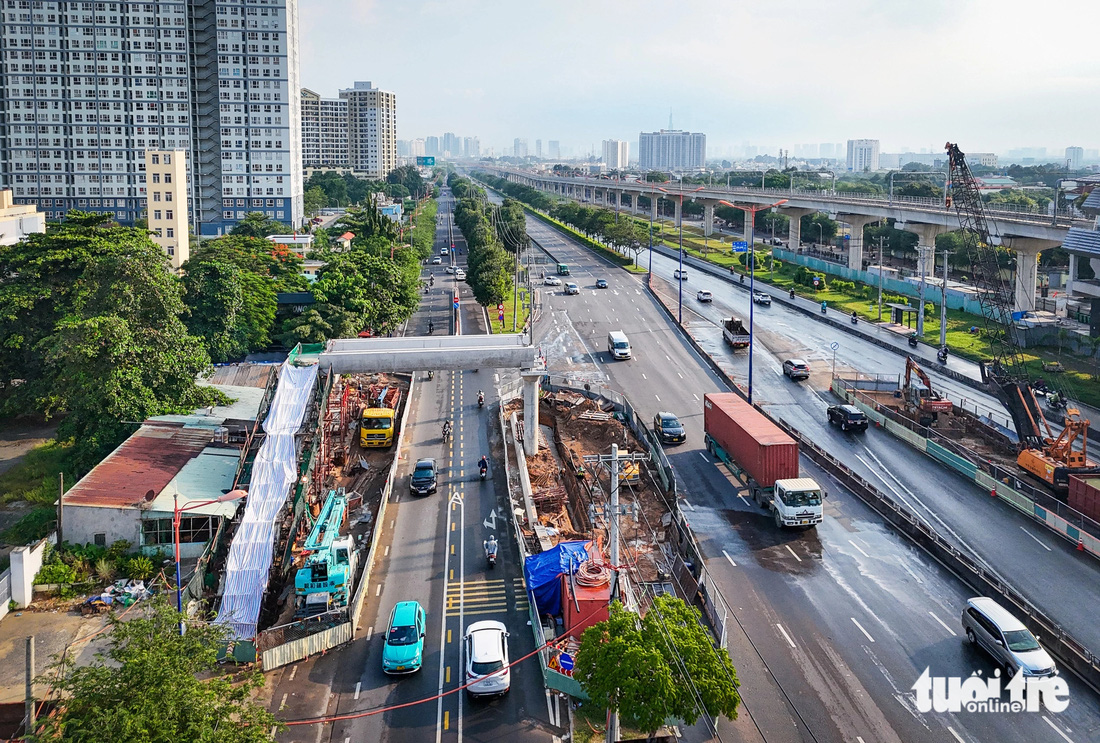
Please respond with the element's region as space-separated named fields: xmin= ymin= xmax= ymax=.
xmin=272 ymin=189 xmax=564 ymax=743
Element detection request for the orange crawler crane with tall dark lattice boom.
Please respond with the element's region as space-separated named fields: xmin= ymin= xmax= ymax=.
xmin=945 ymin=142 xmax=1100 ymax=493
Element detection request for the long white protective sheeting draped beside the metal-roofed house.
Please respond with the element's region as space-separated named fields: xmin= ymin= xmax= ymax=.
xmin=216 ymin=363 xmax=317 ymax=640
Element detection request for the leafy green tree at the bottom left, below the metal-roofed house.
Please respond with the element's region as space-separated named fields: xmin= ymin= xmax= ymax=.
xmin=28 ymin=597 xmax=279 ymax=743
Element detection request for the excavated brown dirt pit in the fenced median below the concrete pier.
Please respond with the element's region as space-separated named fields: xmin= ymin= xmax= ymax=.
xmin=505 ymin=391 xmax=671 ymax=582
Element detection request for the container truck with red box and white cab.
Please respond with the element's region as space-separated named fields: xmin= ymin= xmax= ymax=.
xmin=703 ymin=392 xmax=825 ymax=527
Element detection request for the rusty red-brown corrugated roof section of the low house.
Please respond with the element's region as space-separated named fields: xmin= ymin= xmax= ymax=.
xmin=63 ymin=424 xmax=215 ymax=509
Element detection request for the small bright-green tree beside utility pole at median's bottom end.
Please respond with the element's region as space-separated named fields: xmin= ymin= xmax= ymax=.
xmin=573 ymin=596 xmax=740 ymax=734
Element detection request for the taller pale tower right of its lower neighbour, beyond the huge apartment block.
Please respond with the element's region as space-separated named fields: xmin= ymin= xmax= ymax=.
xmin=340 ymin=81 xmax=397 ymax=178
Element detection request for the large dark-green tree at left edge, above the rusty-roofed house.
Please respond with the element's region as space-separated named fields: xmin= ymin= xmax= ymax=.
xmin=0 ymin=212 xmax=220 ymax=470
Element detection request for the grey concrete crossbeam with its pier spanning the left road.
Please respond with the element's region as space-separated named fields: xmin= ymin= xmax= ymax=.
xmin=318 ymin=334 xmax=547 ymax=457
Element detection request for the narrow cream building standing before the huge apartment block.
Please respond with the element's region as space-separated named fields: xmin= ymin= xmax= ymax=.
xmin=145 ymin=150 xmax=191 ymax=271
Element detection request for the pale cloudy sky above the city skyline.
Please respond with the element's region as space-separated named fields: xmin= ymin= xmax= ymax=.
xmin=298 ymin=0 xmax=1100 ymax=156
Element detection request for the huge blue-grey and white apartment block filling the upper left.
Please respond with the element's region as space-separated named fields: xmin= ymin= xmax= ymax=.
xmin=0 ymin=0 xmax=303 ymax=234
